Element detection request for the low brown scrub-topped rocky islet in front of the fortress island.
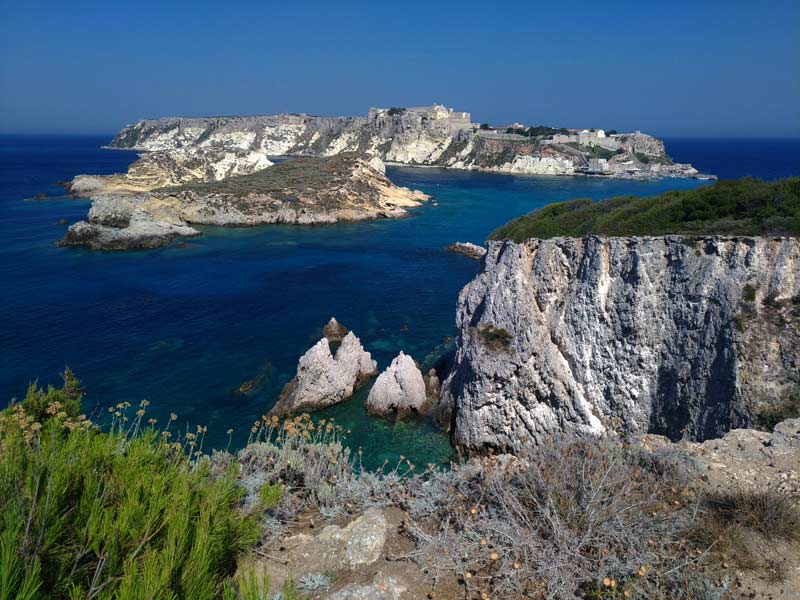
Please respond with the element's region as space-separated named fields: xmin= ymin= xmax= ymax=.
xmin=63 ymin=154 xmax=428 ymax=249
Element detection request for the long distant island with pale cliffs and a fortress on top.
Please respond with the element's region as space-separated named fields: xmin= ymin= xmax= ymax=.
xmin=110 ymin=105 xmax=697 ymax=177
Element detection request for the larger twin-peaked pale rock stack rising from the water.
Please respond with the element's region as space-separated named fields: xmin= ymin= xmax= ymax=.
xmin=269 ymin=332 xmax=378 ymax=417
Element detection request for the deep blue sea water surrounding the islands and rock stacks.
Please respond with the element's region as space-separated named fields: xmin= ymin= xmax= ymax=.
xmin=0 ymin=136 xmax=800 ymax=465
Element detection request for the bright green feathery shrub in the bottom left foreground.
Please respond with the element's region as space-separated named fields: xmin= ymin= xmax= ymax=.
xmin=0 ymin=372 xmax=257 ymax=599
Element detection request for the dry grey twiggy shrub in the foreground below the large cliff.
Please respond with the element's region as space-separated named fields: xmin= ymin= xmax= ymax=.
xmin=407 ymin=440 xmax=712 ymax=598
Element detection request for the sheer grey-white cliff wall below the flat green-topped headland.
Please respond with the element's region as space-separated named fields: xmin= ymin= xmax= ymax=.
xmin=443 ymin=236 xmax=800 ymax=449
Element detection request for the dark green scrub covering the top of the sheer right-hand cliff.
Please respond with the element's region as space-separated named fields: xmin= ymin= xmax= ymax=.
xmin=490 ymin=177 xmax=800 ymax=242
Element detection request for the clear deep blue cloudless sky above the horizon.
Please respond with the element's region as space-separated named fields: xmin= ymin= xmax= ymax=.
xmin=0 ymin=0 xmax=800 ymax=137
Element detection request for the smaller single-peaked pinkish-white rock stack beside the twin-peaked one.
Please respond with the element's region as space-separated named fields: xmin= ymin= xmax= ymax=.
xmin=367 ymin=351 xmax=426 ymax=415
